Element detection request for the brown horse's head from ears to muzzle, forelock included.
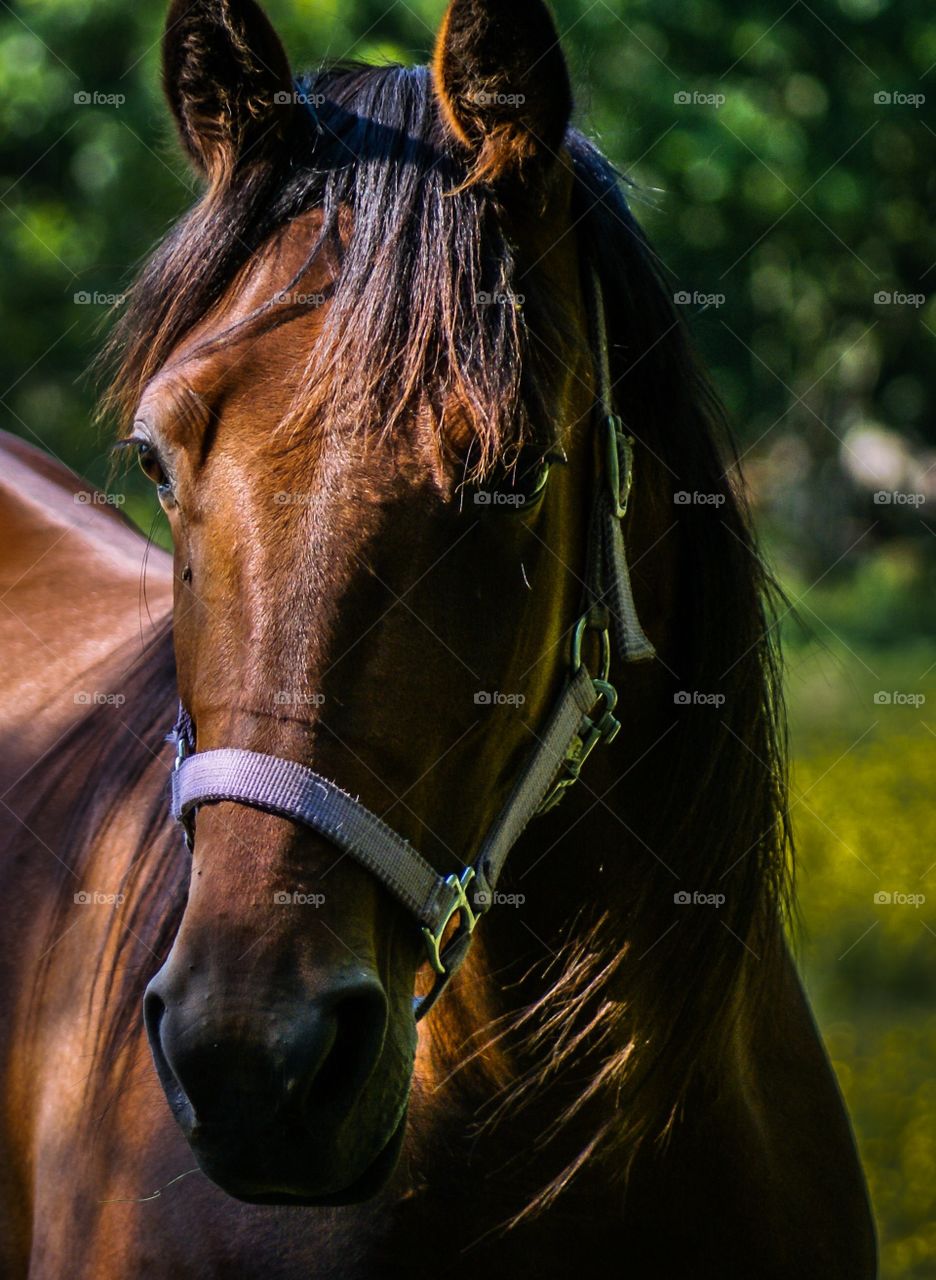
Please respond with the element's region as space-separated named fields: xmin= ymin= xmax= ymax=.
xmin=137 ymin=0 xmax=622 ymax=1203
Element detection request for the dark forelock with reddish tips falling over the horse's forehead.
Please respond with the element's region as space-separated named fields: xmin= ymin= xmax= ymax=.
xmin=104 ymin=67 xmax=586 ymax=475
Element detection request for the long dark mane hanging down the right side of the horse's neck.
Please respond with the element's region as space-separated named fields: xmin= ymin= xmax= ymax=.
xmin=440 ymin=131 xmax=793 ymax=1226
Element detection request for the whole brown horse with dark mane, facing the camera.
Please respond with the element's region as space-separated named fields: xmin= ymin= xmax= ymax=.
xmin=0 ymin=0 xmax=875 ymax=1280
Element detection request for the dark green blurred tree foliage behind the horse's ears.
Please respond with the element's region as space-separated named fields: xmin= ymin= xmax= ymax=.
xmin=0 ymin=0 xmax=936 ymax=514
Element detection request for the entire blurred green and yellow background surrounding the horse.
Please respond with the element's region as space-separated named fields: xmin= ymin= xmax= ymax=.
xmin=0 ymin=0 xmax=936 ymax=1280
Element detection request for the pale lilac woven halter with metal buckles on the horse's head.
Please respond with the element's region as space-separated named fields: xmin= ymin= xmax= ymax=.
xmin=172 ymin=270 xmax=656 ymax=1020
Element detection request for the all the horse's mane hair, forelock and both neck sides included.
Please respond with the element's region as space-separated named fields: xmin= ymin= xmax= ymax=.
xmin=31 ymin=67 xmax=790 ymax=1216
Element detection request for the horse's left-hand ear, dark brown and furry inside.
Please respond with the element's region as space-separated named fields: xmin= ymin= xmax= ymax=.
xmin=163 ymin=0 xmax=297 ymax=182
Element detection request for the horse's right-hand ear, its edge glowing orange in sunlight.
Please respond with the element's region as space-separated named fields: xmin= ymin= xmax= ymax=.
xmin=433 ymin=0 xmax=572 ymax=182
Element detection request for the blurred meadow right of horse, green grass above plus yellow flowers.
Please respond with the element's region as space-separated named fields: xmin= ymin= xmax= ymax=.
xmin=781 ymin=583 xmax=936 ymax=1280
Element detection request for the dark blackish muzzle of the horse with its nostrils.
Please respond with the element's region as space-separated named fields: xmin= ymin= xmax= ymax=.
xmin=143 ymin=956 xmax=411 ymax=1203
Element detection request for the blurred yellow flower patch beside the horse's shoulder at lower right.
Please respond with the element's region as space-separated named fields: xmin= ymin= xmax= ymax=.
xmin=794 ymin=709 xmax=936 ymax=1280
